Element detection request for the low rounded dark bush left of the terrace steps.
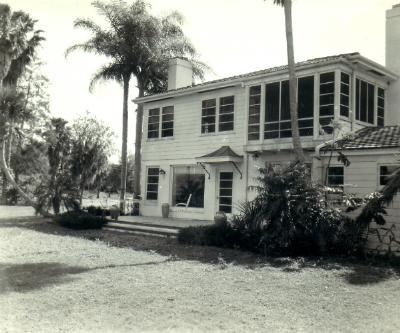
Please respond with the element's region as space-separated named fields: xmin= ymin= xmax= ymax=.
xmin=55 ymin=211 xmax=107 ymax=229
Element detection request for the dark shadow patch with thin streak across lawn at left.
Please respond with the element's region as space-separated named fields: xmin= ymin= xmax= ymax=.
xmin=0 ymin=259 xmax=170 ymax=294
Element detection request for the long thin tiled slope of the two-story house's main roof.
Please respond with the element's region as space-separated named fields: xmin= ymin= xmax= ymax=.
xmin=146 ymin=52 xmax=360 ymax=96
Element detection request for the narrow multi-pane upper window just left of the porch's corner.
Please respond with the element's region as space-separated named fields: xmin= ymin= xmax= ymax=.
xmin=319 ymin=72 xmax=335 ymax=133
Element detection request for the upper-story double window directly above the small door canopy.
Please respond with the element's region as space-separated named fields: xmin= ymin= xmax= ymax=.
xmin=201 ymin=96 xmax=235 ymax=134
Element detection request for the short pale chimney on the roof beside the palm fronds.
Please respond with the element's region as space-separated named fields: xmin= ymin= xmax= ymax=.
xmin=168 ymin=58 xmax=193 ymax=90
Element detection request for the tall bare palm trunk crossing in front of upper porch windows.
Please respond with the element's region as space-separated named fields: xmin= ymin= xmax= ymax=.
xmin=284 ymin=0 xmax=305 ymax=163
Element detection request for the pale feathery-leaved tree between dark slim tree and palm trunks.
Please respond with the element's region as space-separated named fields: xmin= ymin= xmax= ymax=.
xmin=71 ymin=114 xmax=114 ymax=204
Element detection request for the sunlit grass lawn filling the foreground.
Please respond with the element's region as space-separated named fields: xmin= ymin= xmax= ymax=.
xmin=0 ymin=219 xmax=400 ymax=332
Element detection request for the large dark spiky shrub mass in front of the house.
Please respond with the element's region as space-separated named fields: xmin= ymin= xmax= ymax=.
xmin=178 ymin=163 xmax=364 ymax=256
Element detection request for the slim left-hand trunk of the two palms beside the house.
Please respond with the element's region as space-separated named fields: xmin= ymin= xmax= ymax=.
xmin=119 ymin=75 xmax=130 ymax=211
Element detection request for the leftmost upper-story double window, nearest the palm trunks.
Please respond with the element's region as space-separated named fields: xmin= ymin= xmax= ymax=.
xmin=147 ymin=106 xmax=174 ymax=139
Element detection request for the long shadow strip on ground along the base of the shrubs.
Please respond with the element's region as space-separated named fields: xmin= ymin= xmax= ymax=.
xmin=0 ymin=220 xmax=400 ymax=285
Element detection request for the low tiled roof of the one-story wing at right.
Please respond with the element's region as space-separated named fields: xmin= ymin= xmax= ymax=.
xmin=323 ymin=126 xmax=400 ymax=150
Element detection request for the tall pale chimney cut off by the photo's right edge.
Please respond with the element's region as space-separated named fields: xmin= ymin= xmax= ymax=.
xmin=385 ymin=4 xmax=400 ymax=125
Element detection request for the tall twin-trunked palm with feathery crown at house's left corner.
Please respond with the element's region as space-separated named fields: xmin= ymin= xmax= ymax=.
xmin=66 ymin=0 xmax=207 ymax=210
